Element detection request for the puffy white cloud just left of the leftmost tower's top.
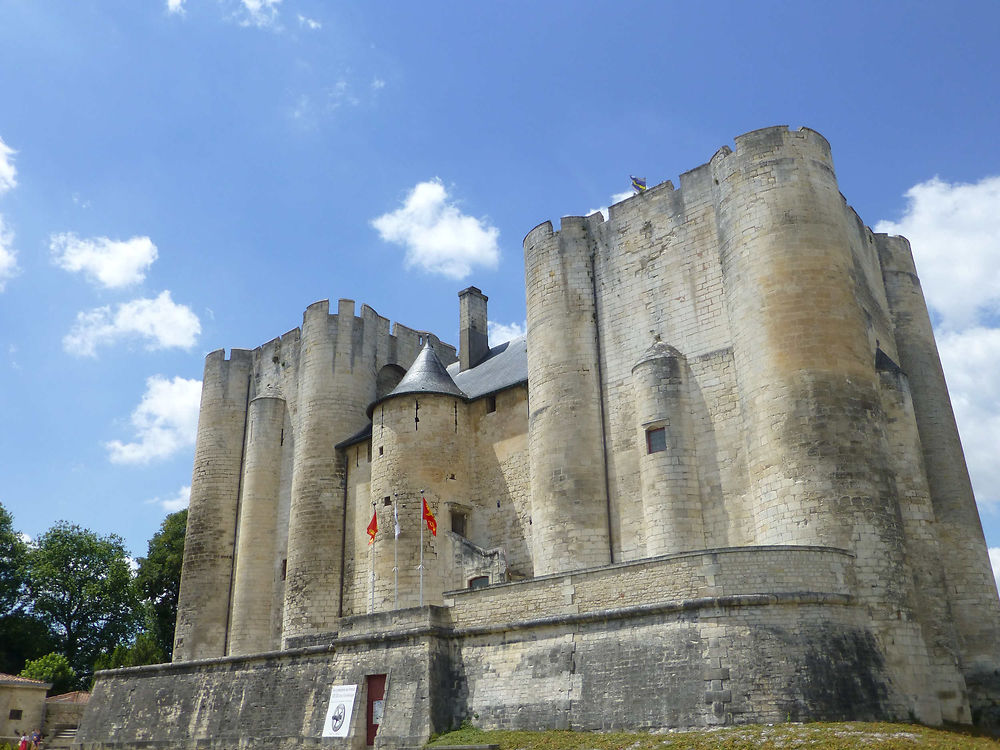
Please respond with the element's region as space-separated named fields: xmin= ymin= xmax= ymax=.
xmin=105 ymin=375 xmax=201 ymax=468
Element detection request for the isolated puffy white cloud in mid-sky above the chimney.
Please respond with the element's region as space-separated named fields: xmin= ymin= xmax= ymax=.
xmin=371 ymin=179 xmax=500 ymax=279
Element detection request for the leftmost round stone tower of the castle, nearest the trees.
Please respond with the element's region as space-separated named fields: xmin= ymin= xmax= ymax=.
xmin=173 ymin=349 xmax=251 ymax=661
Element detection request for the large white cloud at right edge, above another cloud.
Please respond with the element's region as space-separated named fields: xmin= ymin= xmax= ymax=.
xmin=875 ymin=177 xmax=1000 ymax=329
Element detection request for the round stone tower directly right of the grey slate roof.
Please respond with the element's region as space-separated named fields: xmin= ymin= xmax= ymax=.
xmin=524 ymin=217 xmax=611 ymax=575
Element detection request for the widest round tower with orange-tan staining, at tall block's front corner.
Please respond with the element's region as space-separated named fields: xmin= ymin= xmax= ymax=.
xmin=710 ymin=127 xmax=941 ymax=723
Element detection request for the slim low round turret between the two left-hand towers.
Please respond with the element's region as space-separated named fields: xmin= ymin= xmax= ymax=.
xmin=228 ymin=395 xmax=285 ymax=655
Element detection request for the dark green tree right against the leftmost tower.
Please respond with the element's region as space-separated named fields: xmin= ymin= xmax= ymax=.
xmin=136 ymin=509 xmax=187 ymax=664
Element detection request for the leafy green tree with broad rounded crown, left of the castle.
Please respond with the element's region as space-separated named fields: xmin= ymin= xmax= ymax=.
xmin=26 ymin=521 xmax=141 ymax=684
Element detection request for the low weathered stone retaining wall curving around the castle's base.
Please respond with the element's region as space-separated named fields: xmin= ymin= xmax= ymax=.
xmin=79 ymin=547 xmax=905 ymax=750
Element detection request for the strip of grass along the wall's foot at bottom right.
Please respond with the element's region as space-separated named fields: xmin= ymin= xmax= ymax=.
xmin=427 ymin=722 xmax=1000 ymax=750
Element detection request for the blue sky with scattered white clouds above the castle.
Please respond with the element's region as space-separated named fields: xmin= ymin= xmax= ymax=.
xmin=0 ymin=0 xmax=1000 ymax=588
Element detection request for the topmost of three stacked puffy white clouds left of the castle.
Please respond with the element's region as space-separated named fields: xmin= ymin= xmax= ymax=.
xmin=49 ymin=232 xmax=157 ymax=289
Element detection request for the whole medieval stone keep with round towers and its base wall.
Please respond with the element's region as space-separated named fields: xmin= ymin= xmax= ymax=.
xmin=80 ymin=127 xmax=1000 ymax=748
